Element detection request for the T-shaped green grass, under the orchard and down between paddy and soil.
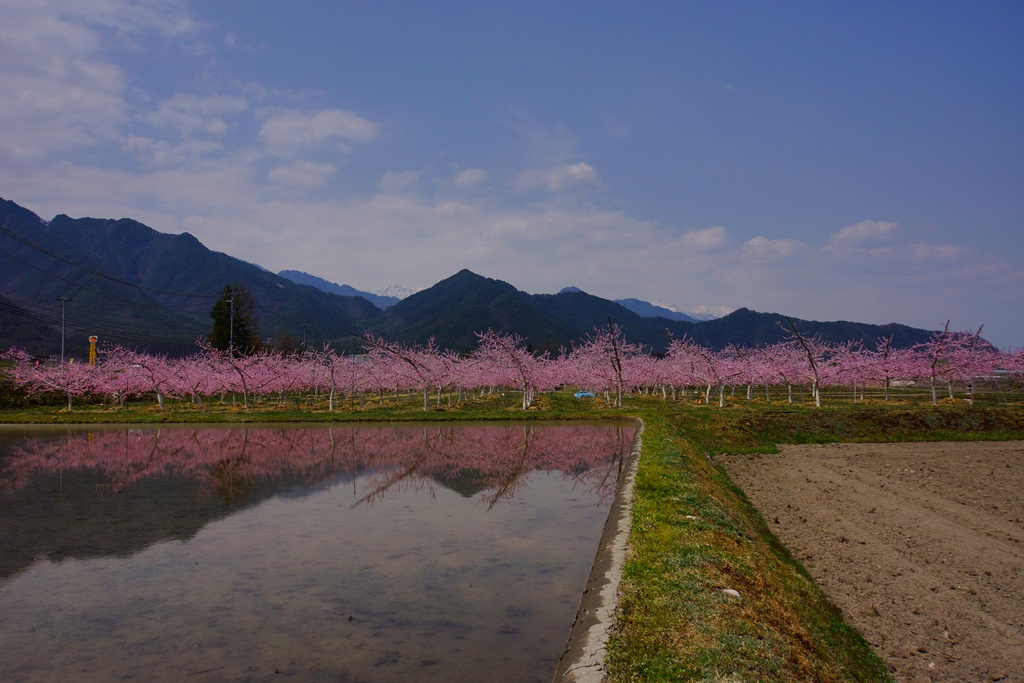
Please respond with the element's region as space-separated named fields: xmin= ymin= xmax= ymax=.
xmin=0 ymin=392 xmax=1024 ymax=683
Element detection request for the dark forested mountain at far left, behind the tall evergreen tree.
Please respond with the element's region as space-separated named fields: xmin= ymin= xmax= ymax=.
xmin=0 ymin=201 xmax=381 ymax=355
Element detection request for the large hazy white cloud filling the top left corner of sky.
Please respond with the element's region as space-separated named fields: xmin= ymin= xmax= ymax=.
xmin=0 ymin=0 xmax=206 ymax=160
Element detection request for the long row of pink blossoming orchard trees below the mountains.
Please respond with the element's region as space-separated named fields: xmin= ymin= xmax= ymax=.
xmin=3 ymin=325 xmax=1024 ymax=411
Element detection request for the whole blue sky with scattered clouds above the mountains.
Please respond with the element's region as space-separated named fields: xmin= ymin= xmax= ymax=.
xmin=0 ymin=0 xmax=1024 ymax=348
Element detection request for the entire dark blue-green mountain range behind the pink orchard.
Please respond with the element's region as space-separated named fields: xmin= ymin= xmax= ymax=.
xmin=0 ymin=194 xmax=931 ymax=356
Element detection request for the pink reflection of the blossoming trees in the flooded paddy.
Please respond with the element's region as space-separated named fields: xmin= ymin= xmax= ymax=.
xmin=0 ymin=425 xmax=633 ymax=507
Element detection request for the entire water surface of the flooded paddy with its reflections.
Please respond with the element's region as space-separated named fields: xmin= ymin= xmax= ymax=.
xmin=0 ymin=425 xmax=632 ymax=680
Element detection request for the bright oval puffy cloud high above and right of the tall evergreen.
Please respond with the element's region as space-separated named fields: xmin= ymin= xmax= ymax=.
xmin=259 ymin=109 xmax=382 ymax=155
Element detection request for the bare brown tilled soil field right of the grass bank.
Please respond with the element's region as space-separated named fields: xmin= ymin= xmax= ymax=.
xmin=720 ymin=441 xmax=1024 ymax=682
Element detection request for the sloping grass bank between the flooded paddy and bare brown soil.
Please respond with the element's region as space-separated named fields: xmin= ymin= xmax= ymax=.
xmin=607 ymin=412 xmax=891 ymax=682
